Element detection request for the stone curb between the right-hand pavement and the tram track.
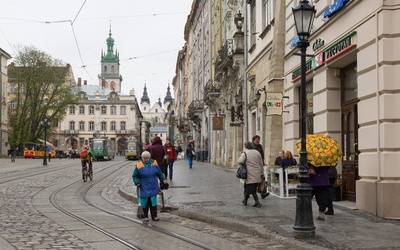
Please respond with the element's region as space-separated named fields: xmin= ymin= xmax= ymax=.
xmin=118 ymin=185 xmax=326 ymax=250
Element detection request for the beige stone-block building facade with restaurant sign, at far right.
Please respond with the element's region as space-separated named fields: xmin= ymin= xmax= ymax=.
xmin=282 ymin=0 xmax=400 ymax=219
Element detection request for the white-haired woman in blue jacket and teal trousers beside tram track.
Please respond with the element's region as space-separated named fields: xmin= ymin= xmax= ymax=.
xmin=132 ymin=149 xmax=167 ymax=222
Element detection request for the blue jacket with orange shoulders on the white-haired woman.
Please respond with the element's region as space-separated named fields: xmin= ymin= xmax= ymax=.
xmin=132 ymin=159 xmax=165 ymax=198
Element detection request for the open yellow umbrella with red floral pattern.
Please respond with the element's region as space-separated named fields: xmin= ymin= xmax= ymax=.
xmin=295 ymin=134 xmax=343 ymax=167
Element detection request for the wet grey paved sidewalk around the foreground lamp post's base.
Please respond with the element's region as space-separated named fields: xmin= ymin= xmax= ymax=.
xmin=119 ymin=160 xmax=400 ymax=249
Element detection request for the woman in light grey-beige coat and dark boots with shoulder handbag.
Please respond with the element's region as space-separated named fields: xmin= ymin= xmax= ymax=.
xmin=238 ymin=142 xmax=263 ymax=207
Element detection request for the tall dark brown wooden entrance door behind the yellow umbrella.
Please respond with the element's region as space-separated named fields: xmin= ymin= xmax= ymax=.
xmin=342 ymin=103 xmax=359 ymax=201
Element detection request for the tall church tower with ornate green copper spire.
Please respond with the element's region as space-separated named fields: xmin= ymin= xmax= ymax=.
xmin=99 ymin=25 xmax=122 ymax=93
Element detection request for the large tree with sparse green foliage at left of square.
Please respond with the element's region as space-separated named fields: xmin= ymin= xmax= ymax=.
xmin=8 ymin=47 xmax=78 ymax=146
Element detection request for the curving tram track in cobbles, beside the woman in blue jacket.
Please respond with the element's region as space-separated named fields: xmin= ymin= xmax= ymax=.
xmin=45 ymin=163 xmax=220 ymax=249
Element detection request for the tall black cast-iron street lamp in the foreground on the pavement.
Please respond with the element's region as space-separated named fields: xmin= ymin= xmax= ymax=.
xmin=292 ymin=0 xmax=316 ymax=237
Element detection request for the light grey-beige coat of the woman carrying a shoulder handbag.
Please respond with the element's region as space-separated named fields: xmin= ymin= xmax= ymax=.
xmin=238 ymin=149 xmax=263 ymax=184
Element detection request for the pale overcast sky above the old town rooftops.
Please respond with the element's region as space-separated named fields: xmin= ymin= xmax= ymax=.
xmin=0 ymin=0 xmax=192 ymax=105
